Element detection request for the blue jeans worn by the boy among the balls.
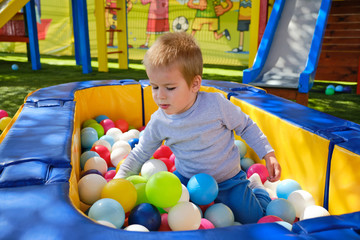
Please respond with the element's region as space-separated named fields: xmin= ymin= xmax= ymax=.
xmin=174 ymin=170 xmax=271 ymax=224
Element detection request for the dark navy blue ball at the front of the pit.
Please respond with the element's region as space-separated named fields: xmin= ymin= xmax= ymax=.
xmin=128 ymin=203 xmax=161 ymax=231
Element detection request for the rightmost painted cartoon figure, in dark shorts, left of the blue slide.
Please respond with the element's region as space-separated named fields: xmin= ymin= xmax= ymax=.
xmin=232 ymin=0 xmax=251 ymax=53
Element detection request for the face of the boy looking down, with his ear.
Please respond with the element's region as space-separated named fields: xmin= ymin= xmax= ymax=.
xmin=146 ymin=66 xmax=201 ymax=114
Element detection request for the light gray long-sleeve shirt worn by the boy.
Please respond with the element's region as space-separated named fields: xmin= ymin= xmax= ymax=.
xmin=116 ymin=92 xmax=274 ymax=182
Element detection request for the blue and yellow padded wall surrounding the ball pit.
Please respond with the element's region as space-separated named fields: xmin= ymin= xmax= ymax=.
xmin=0 ymin=79 xmax=360 ymax=240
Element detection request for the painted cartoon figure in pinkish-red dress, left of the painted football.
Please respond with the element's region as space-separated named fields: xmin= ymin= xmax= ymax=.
xmin=140 ymin=0 xmax=169 ymax=49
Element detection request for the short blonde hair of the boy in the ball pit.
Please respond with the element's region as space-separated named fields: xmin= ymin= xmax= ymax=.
xmin=143 ymin=33 xmax=203 ymax=86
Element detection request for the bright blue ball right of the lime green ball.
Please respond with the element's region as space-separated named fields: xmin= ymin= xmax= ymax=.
xmin=186 ymin=173 xmax=219 ymax=205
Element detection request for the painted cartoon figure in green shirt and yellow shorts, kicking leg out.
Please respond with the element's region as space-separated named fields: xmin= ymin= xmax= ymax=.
xmin=187 ymin=0 xmax=233 ymax=40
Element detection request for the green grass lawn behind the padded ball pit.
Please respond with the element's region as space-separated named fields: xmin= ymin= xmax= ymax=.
xmin=0 ymin=53 xmax=360 ymax=124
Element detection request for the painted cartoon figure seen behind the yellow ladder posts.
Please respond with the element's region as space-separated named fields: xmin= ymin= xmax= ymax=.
xmin=105 ymin=0 xmax=133 ymax=48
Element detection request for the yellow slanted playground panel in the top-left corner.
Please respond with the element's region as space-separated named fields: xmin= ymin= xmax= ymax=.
xmin=0 ymin=0 xmax=29 ymax=28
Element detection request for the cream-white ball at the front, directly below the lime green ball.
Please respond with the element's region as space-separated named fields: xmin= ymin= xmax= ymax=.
xmin=168 ymin=202 xmax=201 ymax=231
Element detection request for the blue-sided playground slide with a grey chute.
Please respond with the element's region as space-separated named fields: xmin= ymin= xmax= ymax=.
xmin=243 ymin=0 xmax=331 ymax=93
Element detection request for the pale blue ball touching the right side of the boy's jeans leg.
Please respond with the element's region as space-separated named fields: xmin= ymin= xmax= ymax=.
xmin=266 ymin=198 xmax=296 ymax=224
